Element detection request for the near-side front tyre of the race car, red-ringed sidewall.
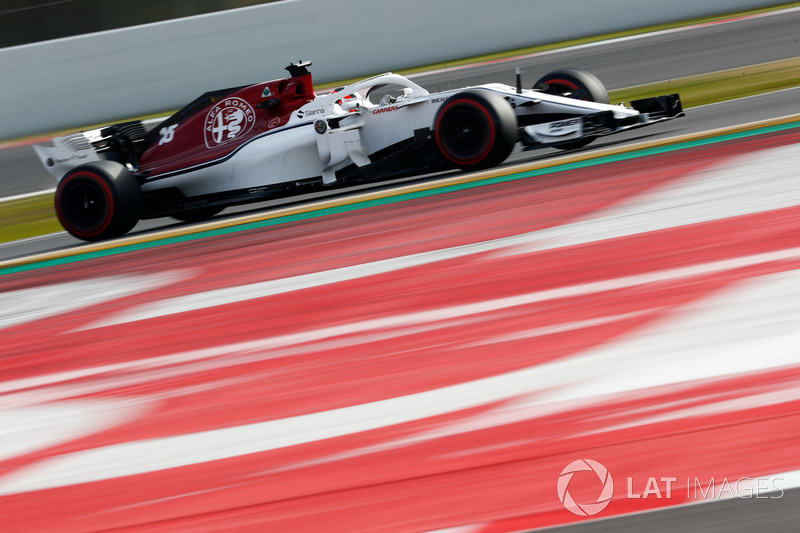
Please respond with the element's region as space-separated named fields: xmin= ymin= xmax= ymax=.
xmin=433 ymin=91 xmax=517 ymax=170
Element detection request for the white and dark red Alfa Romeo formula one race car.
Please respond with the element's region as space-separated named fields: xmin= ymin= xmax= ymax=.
xmin=34 ymin=62 xmax=683 ymax=241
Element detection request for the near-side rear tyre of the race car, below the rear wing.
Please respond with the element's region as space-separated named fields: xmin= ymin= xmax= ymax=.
xmin=55 ymin=161 xmax=142 ymax=241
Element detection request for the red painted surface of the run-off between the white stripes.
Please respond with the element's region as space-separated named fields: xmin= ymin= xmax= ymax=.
xmin=0 ymin=129 xmax=800 ymax=531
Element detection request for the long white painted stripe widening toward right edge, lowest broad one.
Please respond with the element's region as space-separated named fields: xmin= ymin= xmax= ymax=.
xmin=0 ymin=270 xmax=800 ymax=495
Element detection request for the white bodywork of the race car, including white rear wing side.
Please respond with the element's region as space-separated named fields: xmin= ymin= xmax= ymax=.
xmin=35 ymin=73 xmax=648 ymax=197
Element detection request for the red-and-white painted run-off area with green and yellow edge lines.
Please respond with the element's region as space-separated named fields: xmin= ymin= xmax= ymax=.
xmin=0 ymin=117 xmax=800 ymax=533
